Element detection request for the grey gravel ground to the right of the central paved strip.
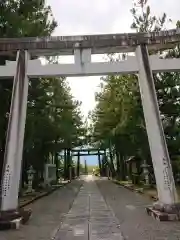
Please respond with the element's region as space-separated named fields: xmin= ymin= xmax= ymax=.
xmin=96 ymin=180 xmax=180 ymax=240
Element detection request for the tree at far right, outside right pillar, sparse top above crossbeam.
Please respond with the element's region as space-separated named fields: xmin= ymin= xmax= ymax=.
xmin=131 ymin=0 xmax=180 ymax=170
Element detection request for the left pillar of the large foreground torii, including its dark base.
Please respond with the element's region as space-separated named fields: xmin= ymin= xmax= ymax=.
xmin=0 ymin=50 xmax=31 ymax=229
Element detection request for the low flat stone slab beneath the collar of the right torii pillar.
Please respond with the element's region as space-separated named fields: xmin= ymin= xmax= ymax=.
xmin=146 ymin=207 xmax=180 ymax=221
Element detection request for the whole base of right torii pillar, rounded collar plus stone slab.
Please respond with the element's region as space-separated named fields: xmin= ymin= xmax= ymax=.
xmin=146 ymin=202 xmax=180 ymax=221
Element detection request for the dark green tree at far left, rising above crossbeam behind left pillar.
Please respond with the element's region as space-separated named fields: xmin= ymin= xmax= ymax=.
xmin=0 ymin=0 xmax=57 ymax=181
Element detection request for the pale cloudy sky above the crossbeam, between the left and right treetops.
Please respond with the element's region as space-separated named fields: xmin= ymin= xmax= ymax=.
xmin=47 ymin=0 xmax=134 ymax=35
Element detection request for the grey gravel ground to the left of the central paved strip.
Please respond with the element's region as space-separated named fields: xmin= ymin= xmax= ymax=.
xmin=0 ymin=180 xmax=83 ymax=240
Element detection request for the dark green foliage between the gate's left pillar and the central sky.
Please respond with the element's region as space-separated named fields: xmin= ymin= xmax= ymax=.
xmin=24 ymin=79 xmax=83 ymax=174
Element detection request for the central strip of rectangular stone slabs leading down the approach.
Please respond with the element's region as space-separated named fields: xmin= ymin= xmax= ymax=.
xmin=55 ymin=176 xmax=123 ymax=240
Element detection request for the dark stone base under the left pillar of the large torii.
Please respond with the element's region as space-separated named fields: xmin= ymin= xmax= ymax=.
xmin=0 ymin=209 xmax=32 ymax=230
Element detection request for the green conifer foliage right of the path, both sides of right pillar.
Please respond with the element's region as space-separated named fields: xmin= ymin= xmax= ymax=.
xmin=90 ymin=0 xmax=180 ymax=179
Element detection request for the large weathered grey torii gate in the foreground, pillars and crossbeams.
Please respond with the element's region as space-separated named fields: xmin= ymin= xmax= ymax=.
xmin=0 ymin=29 xmax=180 ymax=227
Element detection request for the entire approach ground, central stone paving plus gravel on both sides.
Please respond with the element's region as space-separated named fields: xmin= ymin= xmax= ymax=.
xmin=0 ymin=176 xmax=180 ymax=240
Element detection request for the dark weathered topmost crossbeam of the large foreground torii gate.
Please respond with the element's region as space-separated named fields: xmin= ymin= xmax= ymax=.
xmin=0 ymin=28 xmax=180 ymax=56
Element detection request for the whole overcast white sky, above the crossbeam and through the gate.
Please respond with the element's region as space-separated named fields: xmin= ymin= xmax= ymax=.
xmin=47 ymin=0 xmax=180 ymax=118
